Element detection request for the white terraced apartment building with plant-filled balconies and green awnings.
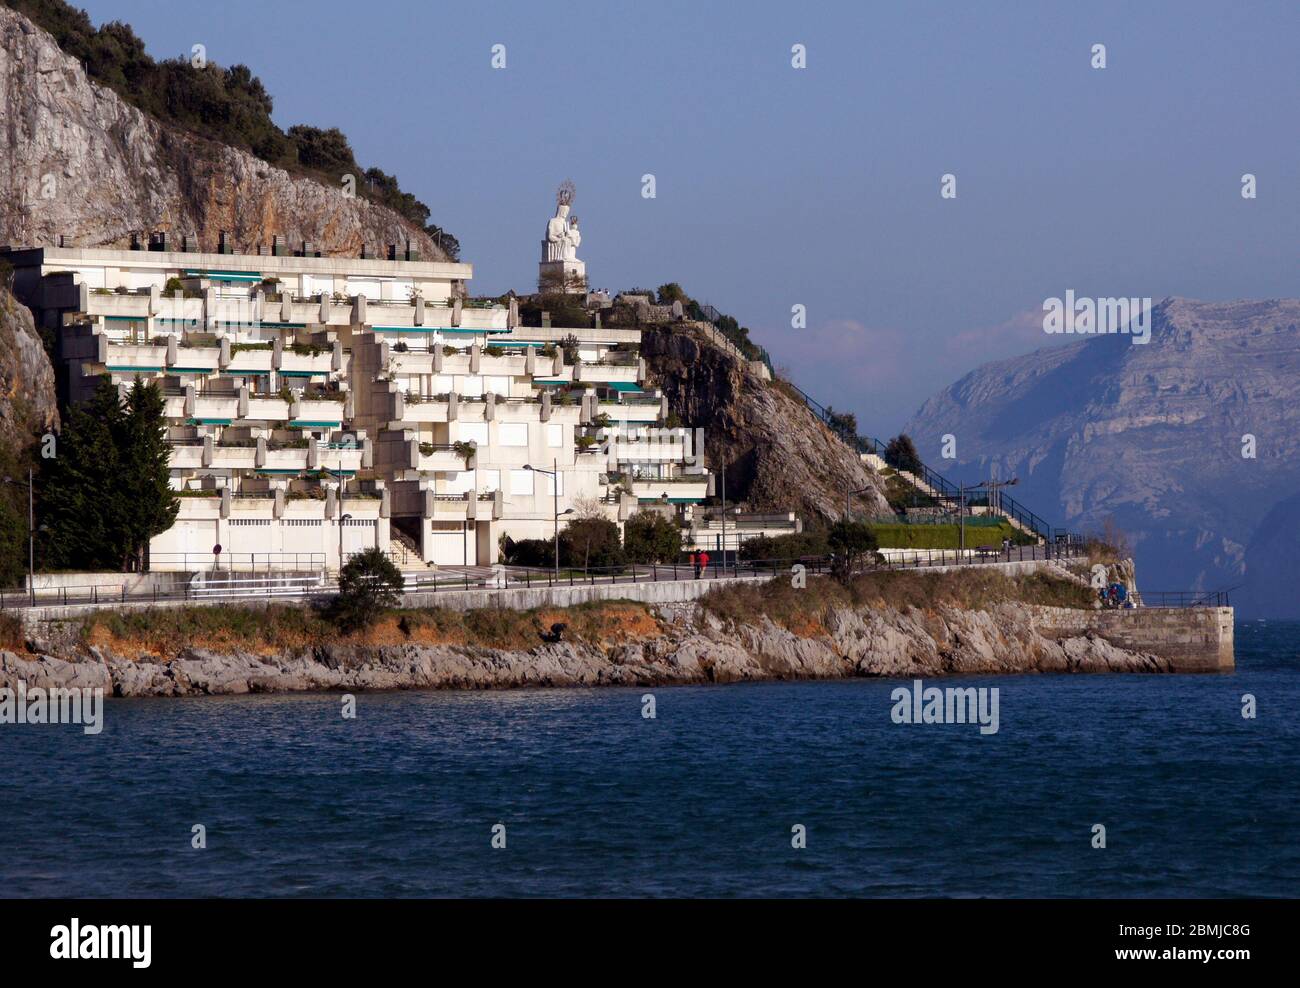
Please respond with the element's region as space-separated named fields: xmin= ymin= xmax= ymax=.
xmin=0 ymin=239 xmax=710 ymax=572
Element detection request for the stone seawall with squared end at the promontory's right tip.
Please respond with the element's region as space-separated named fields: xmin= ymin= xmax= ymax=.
xmin=1034 ymin=607 xmax=1236 ymax=672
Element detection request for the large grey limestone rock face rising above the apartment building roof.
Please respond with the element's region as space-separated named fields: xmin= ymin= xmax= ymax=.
xmin=0 ymin=7 xmax=445 ymax=260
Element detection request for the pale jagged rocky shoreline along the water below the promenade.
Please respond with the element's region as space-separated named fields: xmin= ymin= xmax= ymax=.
xmin=0 ymin=603 xmax=1231 ymax=697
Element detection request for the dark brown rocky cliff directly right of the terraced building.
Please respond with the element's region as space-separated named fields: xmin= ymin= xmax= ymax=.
xmin=641 ymin=322 xmax=889 ymax=521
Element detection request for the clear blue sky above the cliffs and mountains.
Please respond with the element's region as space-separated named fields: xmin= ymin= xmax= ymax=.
xmin=79 ymin=0 xmax=1300 ymax=437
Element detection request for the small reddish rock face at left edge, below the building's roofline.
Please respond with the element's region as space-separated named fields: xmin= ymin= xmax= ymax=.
xmin=0 ymin=287 xmax=59 ymax=449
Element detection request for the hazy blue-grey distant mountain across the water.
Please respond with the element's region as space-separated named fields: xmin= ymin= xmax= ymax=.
xmin=907 ymin=298 xmax=1300 ymax=618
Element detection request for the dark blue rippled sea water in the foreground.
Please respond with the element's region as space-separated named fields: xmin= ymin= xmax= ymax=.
xmin=0 ymin=623 xmax=1300 ymax=897
